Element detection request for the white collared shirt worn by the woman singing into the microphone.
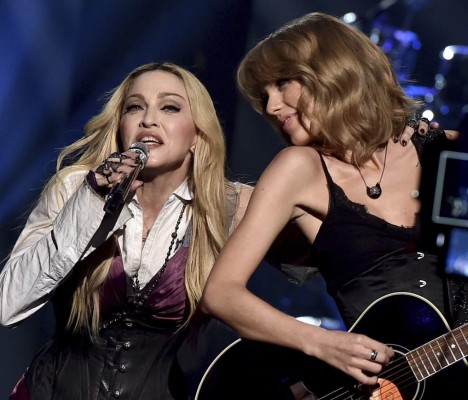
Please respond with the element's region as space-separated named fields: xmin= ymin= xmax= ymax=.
xmin=0 ymin=171 xmax=192 ymax=326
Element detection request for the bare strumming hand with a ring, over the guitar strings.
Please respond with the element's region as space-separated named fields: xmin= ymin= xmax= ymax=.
xmin=315 ymin=331 xmax=394 ymax=385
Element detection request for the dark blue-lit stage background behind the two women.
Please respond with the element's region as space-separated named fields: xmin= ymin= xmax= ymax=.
xmin=0 ymin=0 xmax=468 ymax=399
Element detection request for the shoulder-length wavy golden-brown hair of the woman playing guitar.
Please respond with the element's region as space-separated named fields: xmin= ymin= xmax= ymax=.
xmin=237 ymin=13 xmax=419 ymax=165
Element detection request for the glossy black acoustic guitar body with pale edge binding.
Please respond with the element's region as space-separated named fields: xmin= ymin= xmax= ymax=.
xmin=195 ymin=293 xmax=468 ymax=400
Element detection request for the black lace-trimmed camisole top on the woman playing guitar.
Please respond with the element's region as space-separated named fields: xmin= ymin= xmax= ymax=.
xmin=312 ymin=155 xmax=415 ymax=294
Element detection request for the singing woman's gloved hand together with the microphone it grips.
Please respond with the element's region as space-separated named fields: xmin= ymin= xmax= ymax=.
xmin=92 ymin=142 xmax=148 ymax=214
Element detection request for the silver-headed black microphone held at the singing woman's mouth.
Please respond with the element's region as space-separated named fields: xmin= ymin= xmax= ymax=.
xmin=104 ymin=142 xmax=149 ymax=214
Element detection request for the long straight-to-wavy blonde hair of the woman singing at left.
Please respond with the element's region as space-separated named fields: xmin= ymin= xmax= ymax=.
xmin=46 ymin=62 xmax=229 ymax=336
